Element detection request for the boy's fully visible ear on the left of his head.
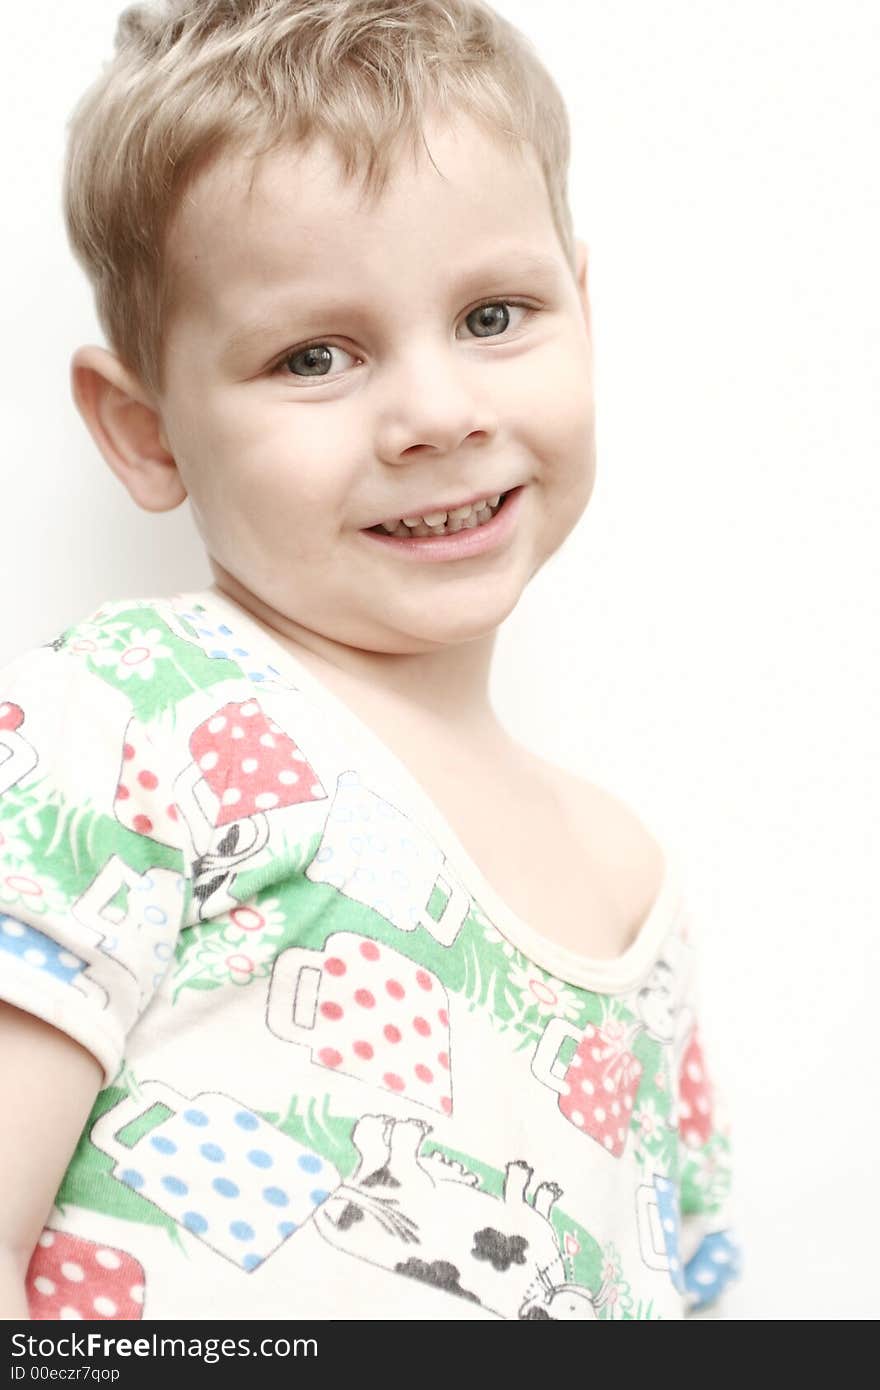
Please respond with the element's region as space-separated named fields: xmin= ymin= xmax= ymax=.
xmin=71 ymin=348 xmax=186 ymax=512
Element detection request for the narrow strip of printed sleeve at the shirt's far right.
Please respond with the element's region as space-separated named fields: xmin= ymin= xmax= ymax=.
xmin=674 ymin=913 xmax=742 ymax=1318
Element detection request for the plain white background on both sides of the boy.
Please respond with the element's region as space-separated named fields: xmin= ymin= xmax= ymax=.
xmin=0 ymin=0 xmax=880 ymax=1319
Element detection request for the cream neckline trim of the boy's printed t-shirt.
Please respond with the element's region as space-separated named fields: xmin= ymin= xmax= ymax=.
xmin=177 ymin=588 xmax=681 ymax=994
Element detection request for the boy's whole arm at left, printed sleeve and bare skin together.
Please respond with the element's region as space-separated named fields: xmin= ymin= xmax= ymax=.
xmin=0 ymin=602 xmax=186 ymax=1318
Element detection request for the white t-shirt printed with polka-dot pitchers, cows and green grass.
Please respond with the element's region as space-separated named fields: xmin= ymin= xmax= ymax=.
xmin=0 ymin=589 xmax=740 ymax=1321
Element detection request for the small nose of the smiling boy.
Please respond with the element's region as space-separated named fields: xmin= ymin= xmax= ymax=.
xmin=375 ymin=339 xmax=498 ymax=463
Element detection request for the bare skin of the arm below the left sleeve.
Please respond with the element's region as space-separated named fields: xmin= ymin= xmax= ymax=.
xmin=0 ymin=1001 xmax=104 ymax=1319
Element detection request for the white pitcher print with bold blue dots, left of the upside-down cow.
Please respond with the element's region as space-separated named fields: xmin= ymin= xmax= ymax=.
xmin=92 ymin=1081 xmax=341 ymax=1270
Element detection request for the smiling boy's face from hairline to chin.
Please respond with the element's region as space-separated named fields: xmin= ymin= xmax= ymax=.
xmin=156 ymin=111 xmax=595 ymax=653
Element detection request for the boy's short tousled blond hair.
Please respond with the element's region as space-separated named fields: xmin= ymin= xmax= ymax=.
xmin=64 ymin=0 xmax=574 ymax=393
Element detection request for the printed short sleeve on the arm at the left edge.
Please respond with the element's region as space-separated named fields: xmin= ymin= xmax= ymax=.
xmin=0 ymin=624 xmax=185 ymax=1083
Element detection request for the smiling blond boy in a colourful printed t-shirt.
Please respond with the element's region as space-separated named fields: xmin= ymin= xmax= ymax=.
xmin=0 ymin=0 xmax=737 ymax=1319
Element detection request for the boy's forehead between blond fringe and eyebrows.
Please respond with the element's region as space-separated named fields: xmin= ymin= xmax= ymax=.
xmin=168 ymin=120 xmax=563 ymax=318
